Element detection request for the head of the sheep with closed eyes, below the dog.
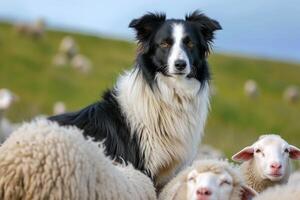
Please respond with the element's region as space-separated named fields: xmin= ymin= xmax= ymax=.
xmin=174 ymin=161 xmax=257 ymax=200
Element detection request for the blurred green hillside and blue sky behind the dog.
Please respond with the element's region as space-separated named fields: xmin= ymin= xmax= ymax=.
xmin=0 ymin=0 xmax=300 ymax=161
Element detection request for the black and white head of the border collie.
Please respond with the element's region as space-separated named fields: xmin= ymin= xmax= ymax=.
xmin=129 ymin=11 xmax=221 ymax=82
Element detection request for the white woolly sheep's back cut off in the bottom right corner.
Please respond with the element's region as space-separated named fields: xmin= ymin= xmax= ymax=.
xmin=254 ymin=183 xmax=300 ymax=200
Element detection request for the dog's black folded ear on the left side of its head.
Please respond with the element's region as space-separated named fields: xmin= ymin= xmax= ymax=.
xmin=129 ymin=13 xmax=166 ymax=42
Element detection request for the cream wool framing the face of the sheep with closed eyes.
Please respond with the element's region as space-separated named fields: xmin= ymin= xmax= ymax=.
xmin=159 ymin=159 xmax=253 ymax=200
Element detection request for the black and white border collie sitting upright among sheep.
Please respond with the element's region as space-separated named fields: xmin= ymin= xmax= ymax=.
xmin=50 ymin=12 xmax=221 ymax=187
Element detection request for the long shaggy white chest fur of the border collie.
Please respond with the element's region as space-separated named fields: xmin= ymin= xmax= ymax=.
xmin=116 ymin=70 xmax=209 ymax=186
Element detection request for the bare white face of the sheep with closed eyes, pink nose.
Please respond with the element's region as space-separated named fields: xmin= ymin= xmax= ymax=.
xmin=187 ymin=170 xmax=233 ymax=200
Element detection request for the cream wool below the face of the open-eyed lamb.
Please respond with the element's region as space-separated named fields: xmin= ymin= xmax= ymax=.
xmin=241 ymin=159 xmax=290 ymax=193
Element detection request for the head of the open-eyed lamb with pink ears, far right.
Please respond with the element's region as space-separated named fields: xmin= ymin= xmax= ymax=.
xmin=232 ymin=135 xmax=300 ymax=181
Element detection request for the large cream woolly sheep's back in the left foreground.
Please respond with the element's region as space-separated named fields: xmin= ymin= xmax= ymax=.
xmin=0 ymin=119 xmax=156 ymax=200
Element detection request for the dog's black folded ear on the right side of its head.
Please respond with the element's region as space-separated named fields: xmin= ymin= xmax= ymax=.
xmin=185 ymin=10 xmax=222 ymax=42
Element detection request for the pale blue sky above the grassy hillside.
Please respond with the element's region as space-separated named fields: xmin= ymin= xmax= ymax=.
xmin=0 ymin=0 xmax=300 ymax=62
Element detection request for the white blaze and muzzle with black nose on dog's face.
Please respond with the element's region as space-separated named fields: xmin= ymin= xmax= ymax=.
xmin=168 ymin=23 xmax=191 ymax=75
